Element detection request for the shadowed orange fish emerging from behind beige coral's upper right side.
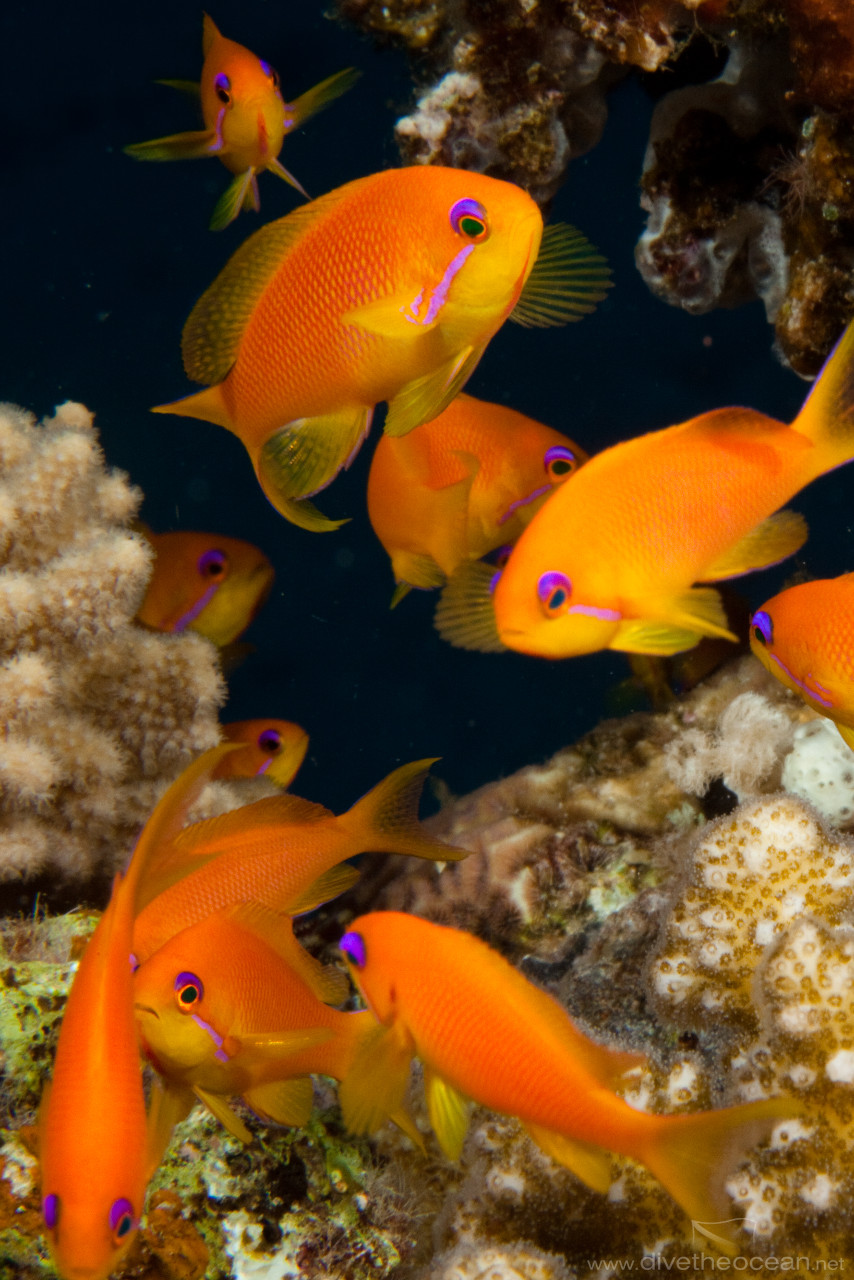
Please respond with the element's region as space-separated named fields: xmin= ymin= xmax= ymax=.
xmin=137 ymin=529 xmax=275 ymax=648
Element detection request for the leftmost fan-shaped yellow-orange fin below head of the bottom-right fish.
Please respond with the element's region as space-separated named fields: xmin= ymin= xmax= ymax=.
xmin=338 ymin=1023 xmax=415 ymax=1133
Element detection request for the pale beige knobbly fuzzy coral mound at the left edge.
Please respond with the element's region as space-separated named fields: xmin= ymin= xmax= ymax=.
xmin=0 ymin=403 xmax=224 ymax=882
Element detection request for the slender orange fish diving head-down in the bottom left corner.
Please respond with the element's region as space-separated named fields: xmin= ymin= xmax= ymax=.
xmin=40 ymin=745 xmax=236 ymax=1280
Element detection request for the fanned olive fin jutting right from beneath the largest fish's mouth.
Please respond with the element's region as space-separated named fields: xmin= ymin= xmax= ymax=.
xmin=510 ymin=223 xmax=612 ymax=328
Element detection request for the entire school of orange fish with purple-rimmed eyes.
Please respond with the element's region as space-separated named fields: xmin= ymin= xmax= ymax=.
xmin=40 ymin=17 xmax=854 ymax=1280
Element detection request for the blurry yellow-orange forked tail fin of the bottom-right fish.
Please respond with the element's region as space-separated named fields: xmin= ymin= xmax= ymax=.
xmin=632 ymin=1098 xmax=800 ymax=1254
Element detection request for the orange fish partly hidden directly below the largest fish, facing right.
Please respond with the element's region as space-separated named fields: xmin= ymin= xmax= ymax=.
xmin=367 ymin=394 xmax=586 ymax=604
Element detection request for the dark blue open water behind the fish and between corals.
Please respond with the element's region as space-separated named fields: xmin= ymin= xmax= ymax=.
xmin=0 ymin=0 xmax=854 ymax=808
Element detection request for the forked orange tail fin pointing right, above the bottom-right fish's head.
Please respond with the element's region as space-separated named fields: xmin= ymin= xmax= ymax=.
xmin=338 ymin=756 xmax=470 ymax=863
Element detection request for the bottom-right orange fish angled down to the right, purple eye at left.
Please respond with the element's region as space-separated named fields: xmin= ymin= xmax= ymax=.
xmin=339 ymin=911 xmax=798 ymax=1252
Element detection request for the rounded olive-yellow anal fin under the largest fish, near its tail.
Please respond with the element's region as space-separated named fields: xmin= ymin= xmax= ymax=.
xmin=255 ymin=404 xmax=373 ymax=501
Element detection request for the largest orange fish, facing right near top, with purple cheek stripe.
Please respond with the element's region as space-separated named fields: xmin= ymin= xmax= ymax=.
xmin=155 ymin=165 xmax=608 ymax=529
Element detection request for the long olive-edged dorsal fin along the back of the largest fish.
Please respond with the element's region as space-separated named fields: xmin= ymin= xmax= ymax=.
xmin=181 ymin=179 xmax=364 ymax=387
